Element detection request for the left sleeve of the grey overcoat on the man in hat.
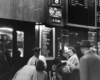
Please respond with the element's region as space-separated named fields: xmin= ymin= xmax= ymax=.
xmin=80 ymin=58 xmax=89 ymax=80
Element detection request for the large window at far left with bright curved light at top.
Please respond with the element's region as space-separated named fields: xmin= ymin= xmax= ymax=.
xmin=0 ymin=27 xmax=13 ymax=67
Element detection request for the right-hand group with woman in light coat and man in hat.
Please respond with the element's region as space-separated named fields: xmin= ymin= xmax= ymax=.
xmin=55 ymin=40 xmax=100 ymax=80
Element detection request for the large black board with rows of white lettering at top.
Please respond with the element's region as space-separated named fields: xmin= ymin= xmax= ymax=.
xmin=68 ymin=0 xmax=88 ymax=25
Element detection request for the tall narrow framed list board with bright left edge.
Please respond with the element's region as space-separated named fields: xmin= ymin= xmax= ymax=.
xmin=39 ymin=25 xmax=55 ymax=60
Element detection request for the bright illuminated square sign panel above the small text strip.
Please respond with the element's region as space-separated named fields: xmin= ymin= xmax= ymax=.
xmin=49 ymin=7 xmax=62 ymax=18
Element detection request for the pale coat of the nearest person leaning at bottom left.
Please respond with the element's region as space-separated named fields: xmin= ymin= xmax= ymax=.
xmin=12 ymin=65 xmax=47 ymax=80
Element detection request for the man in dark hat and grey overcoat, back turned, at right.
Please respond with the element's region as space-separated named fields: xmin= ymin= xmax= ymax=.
xmin=80 ymin=40 xmax=100 ymax=80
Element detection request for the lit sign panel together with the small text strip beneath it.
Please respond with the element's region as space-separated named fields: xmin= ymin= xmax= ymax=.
xmin=48 ymin=6 xmax=64 ymax=26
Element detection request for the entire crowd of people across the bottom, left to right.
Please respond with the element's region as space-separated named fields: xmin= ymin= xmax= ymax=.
xmin=0 ymin=40 xmax=100 ymax=80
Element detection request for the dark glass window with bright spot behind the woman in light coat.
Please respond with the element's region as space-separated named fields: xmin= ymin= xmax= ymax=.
xmin=56 ymin=28 xmax=88 ymax=60
